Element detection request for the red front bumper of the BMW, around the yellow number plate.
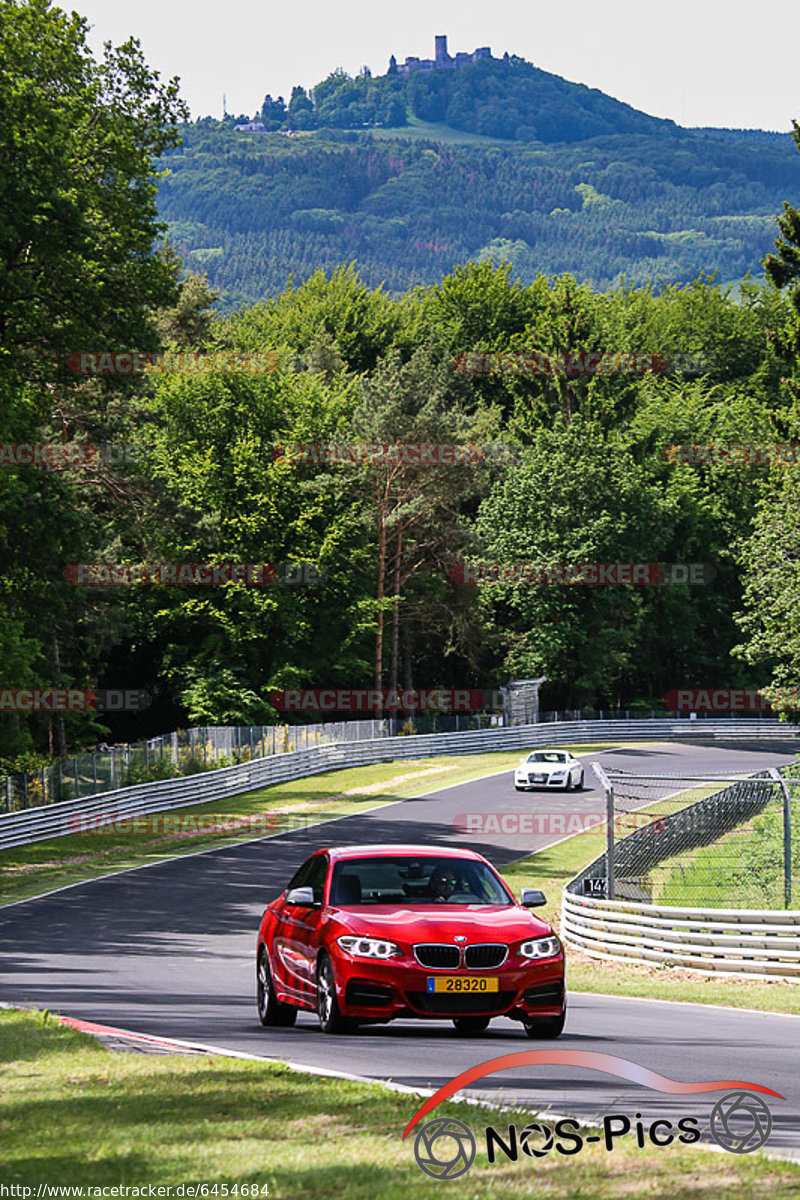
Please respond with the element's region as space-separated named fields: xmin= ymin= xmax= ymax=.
xmin=333 ymin=954 xmax=565 ymax=1021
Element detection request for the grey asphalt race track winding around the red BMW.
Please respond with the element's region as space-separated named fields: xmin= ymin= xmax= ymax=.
xmin=0 ymin=743 xmax=800 ymax=1157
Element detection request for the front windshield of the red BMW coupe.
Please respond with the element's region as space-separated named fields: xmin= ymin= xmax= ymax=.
xmin=331 ymin=854 xmax=515 ymax=907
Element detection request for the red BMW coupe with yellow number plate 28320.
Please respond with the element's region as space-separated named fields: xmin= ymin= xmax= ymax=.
xmin=257 ymin=846 xmax=566 ymax=1038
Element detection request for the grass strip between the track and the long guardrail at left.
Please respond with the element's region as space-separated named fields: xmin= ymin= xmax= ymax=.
xmin=0 ymin=745 xmax=608 ymax=905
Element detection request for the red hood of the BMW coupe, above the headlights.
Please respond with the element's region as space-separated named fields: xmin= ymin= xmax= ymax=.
xmin=335 ymin=904 xmax=552 ymax=943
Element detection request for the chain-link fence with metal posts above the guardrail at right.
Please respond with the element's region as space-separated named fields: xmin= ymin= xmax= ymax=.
xmin=571 ymin=767 xmax=800 ymax=908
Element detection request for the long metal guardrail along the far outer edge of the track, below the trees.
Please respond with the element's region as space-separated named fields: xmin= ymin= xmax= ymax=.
xmin=0 ymin=719 xmax=800 ymax=850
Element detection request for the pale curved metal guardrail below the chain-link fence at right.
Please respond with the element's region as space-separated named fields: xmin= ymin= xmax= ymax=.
xmin=561 ymin=888 xmax=800 ymax=979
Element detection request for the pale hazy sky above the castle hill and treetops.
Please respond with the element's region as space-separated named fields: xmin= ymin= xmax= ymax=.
xmin=71 ymin=0 xmax=800 ymax=130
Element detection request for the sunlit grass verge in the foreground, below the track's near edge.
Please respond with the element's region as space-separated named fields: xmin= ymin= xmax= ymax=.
xmin=0 ymin=1013 xmax=800 ymax=1200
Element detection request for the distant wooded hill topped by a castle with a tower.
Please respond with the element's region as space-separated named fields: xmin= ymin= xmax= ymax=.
xmin=160 ymin=58 xmax=800 ymax=307
